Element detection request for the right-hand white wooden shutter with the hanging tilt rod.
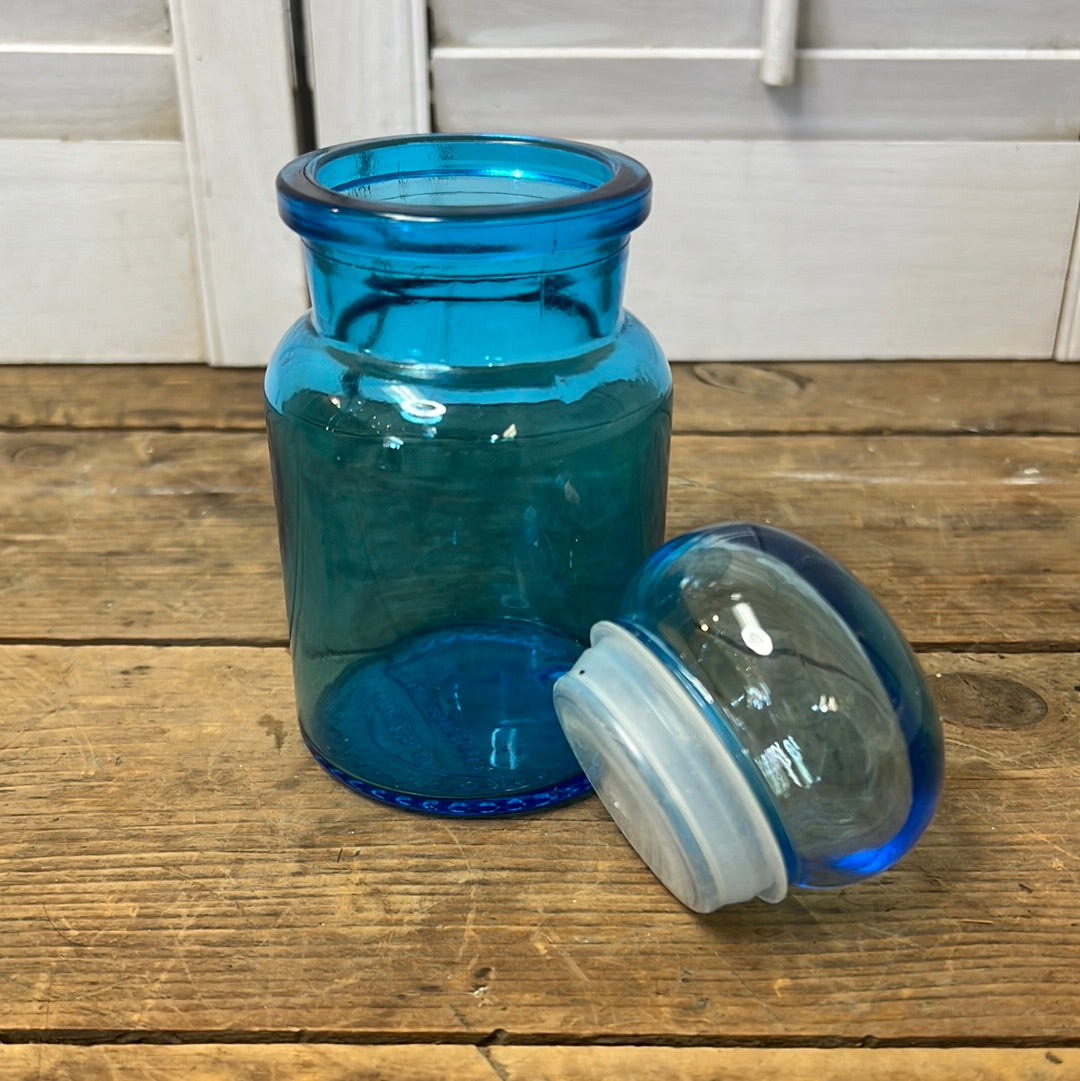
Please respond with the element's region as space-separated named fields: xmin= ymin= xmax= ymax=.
xmin=308 ymin=0 xmax=1080 ymax=359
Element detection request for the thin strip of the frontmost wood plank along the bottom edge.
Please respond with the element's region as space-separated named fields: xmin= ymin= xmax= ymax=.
xmin=0 ymin=1043 xmax=1080 ymax=1081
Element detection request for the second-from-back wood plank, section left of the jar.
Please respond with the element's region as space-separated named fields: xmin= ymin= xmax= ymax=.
xmin=0 ymin=431 xmax=283 ymax=639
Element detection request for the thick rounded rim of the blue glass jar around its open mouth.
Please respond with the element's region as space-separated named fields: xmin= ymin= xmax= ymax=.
xmin=278 ymin=134 xmax=652 ymax=250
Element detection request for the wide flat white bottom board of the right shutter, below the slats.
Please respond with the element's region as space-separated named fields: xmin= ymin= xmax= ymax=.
xmin=615 ymin=141 xmax=1080 ymax=360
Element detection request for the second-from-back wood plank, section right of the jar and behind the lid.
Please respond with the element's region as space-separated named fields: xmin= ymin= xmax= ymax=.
xmin=668 ymin=437 xmax=1080 ymax=645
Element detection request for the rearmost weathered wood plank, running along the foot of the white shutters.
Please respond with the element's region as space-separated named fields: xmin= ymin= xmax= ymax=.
xmin=0 ymin=360 xmax=1080 ymax=436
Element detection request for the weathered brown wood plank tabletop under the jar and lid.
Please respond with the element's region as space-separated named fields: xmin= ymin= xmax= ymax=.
xmin=0 ymin=363 xmax=1080 ymax=1081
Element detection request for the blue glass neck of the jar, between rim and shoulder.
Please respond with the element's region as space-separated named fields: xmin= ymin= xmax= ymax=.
xmin=305 ymin=236 xmax=627 ymax=366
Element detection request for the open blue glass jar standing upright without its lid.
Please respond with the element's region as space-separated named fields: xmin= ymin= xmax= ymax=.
xmin=266 ymin=135 xmax=670 ymax=815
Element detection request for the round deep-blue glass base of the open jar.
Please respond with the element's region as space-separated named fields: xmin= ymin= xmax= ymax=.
xmin=301 ymin=619 xmax=590 ymax=817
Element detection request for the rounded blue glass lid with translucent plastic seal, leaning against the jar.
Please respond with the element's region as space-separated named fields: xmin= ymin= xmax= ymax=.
xmin=555 ymin=523 xmax=943 ymax=912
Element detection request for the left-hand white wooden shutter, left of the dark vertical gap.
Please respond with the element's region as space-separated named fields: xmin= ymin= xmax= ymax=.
xmin=0 ymin=0 xmax=306 ymax=364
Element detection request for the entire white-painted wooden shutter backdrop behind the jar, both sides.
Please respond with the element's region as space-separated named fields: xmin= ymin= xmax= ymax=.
xmin=0 ymin=0 xmax=1080 ymax=364
